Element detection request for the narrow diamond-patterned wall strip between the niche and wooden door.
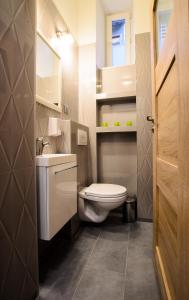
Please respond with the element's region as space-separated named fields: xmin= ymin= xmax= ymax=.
xmin=136 ymin=33 xmax=153 ymax=220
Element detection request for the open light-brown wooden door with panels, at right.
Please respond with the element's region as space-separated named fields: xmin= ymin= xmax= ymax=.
xmin=152 ymin=0 xmax=189 ymax=300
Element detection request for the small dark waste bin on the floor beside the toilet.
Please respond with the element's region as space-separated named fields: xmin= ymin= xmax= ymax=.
xmin=123 ymin=197 xmax=137 ymax=223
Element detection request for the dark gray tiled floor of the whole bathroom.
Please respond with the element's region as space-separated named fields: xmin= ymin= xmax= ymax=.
xmin=40 ymin=217 xmax=161 ymax=300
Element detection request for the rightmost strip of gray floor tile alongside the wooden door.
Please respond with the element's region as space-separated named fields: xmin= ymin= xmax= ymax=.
xmin=125 ymin=223 xmax=161 ymax=300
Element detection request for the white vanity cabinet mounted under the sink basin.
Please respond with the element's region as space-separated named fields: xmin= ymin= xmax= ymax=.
xmin=37 ymin=154 xmax=77 ymax=240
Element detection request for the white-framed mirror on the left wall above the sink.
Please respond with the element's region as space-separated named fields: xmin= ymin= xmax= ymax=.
xmin=36 ymin=32 xmax=62 ymax=112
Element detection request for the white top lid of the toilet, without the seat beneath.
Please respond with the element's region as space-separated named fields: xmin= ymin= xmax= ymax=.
xmin=85 ymin=183 xmax=127 ymax=198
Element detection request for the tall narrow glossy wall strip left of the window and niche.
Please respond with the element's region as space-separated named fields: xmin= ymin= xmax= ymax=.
xmin=78 ymin=0 xmax=97 ymax=181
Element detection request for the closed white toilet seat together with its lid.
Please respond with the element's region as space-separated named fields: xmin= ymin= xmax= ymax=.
xmin=79 ymin=183 xmax=127 ymax=203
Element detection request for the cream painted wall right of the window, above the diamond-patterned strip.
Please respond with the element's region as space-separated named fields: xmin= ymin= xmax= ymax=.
xmin=133 ymin=0 xmax=153 ymax=34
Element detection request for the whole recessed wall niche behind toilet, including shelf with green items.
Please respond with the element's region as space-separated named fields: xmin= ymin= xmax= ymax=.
xmin=96 ymin=91 xmax=137 ymax=194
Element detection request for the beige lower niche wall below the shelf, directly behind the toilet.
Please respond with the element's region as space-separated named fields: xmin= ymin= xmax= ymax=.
xmin=97 ymin=133 xmax=137 ymax=196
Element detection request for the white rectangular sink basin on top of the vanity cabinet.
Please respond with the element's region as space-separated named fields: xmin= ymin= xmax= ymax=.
xmin=36 ymin=154 xmax=77 ymax=167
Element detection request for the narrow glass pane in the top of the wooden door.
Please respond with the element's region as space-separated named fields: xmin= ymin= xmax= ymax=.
xmin=156 ymin=0 xmax=173 ymax=57
